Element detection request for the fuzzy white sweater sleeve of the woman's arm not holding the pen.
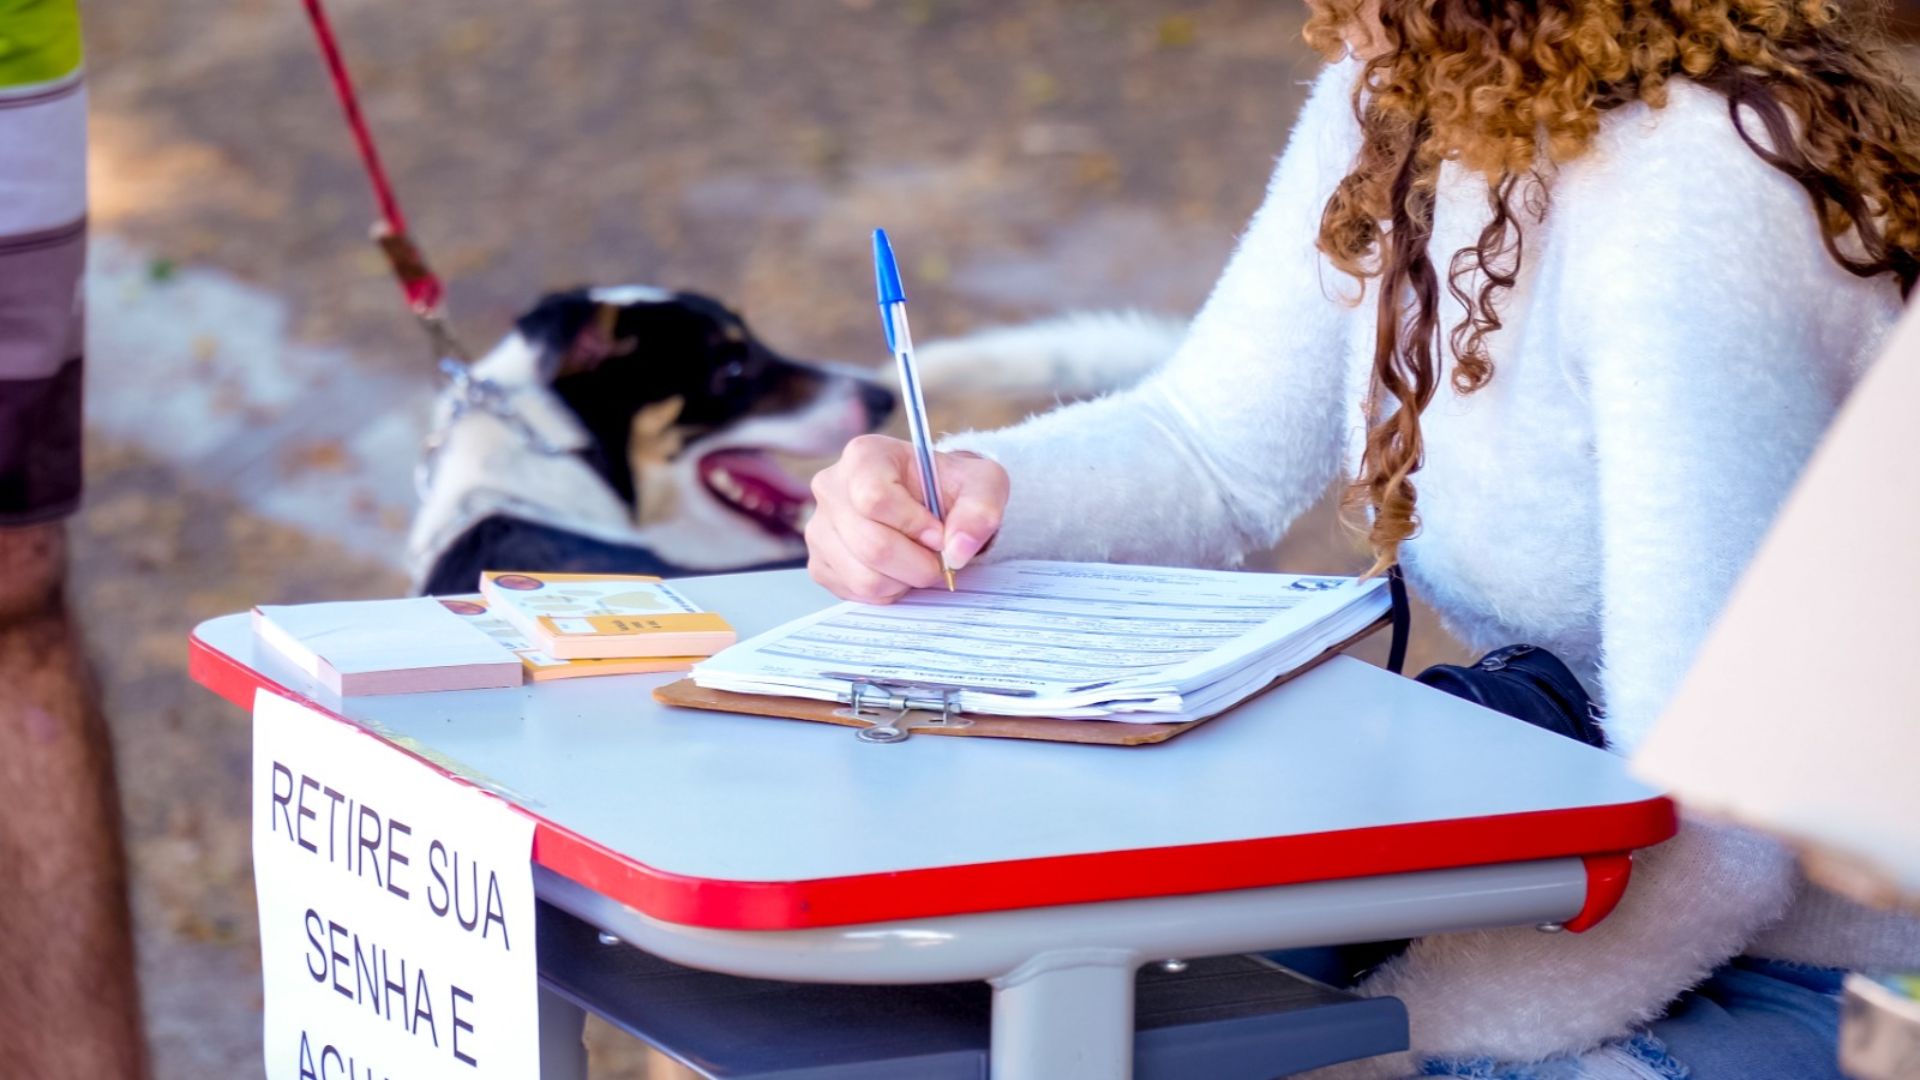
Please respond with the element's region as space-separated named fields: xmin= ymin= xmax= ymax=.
xmin=1313 ymin=88 xmax=1897 ymax=1076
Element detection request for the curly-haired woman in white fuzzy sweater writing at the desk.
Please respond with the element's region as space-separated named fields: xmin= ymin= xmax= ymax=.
xmin=808 ymin=0 xmax=1920 ymax=1080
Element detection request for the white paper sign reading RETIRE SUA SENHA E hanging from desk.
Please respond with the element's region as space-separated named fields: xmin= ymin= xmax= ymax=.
xmin=253 ymin=690 xmax=540 ymax=1080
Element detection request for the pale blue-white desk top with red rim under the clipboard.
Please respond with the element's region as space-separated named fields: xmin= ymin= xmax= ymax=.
xmin=194 ymin=571 xmax=1672 ymax=926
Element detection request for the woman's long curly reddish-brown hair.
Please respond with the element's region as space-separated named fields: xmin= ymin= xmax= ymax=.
xmin=1306 ymin=0 xmax=1920 ymax=573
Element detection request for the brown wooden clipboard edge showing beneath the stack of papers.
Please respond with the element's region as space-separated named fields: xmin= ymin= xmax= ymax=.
xmin=653 ymin=615 xmax=1390 ymax=746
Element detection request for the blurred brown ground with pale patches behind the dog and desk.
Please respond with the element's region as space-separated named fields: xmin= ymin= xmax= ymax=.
xmin=75 ymin=0 xmax=1451 ymax=1080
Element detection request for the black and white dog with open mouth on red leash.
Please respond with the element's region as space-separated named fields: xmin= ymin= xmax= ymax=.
xmin=409 ymin=286 xmax=893 ymax=594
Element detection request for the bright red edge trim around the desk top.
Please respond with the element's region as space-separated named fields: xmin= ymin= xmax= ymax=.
xmin=188 ymin=632 xmax=1678 ymax=930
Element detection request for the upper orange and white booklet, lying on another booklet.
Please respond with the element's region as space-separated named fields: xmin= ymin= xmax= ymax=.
xmin=480 ymin=571 xmax=737 ymax=659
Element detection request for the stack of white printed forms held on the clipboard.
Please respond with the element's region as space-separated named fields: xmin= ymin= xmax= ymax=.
xmin=693 ymin=561 xmax=1388 ymax=723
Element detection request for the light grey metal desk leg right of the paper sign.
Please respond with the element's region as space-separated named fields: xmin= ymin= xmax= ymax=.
xmin=989 ymin=949 xmax=1140 ymax=1080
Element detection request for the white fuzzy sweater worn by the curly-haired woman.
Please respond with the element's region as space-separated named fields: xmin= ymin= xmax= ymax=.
xmin=948 ymin=61 xmax=1920 ymax=1074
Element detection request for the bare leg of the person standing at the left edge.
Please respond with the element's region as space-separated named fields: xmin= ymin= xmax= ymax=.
xmin=0 ymin=523 xmax=146 ymax=1080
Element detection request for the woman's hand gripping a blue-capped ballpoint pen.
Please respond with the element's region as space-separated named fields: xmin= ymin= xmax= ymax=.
xmin=806 ymin=233 xmax=1008 ymax=603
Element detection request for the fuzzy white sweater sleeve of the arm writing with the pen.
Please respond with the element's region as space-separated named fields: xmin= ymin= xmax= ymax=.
xmin=943 ymin=61 xmax=1359 ymax=565
